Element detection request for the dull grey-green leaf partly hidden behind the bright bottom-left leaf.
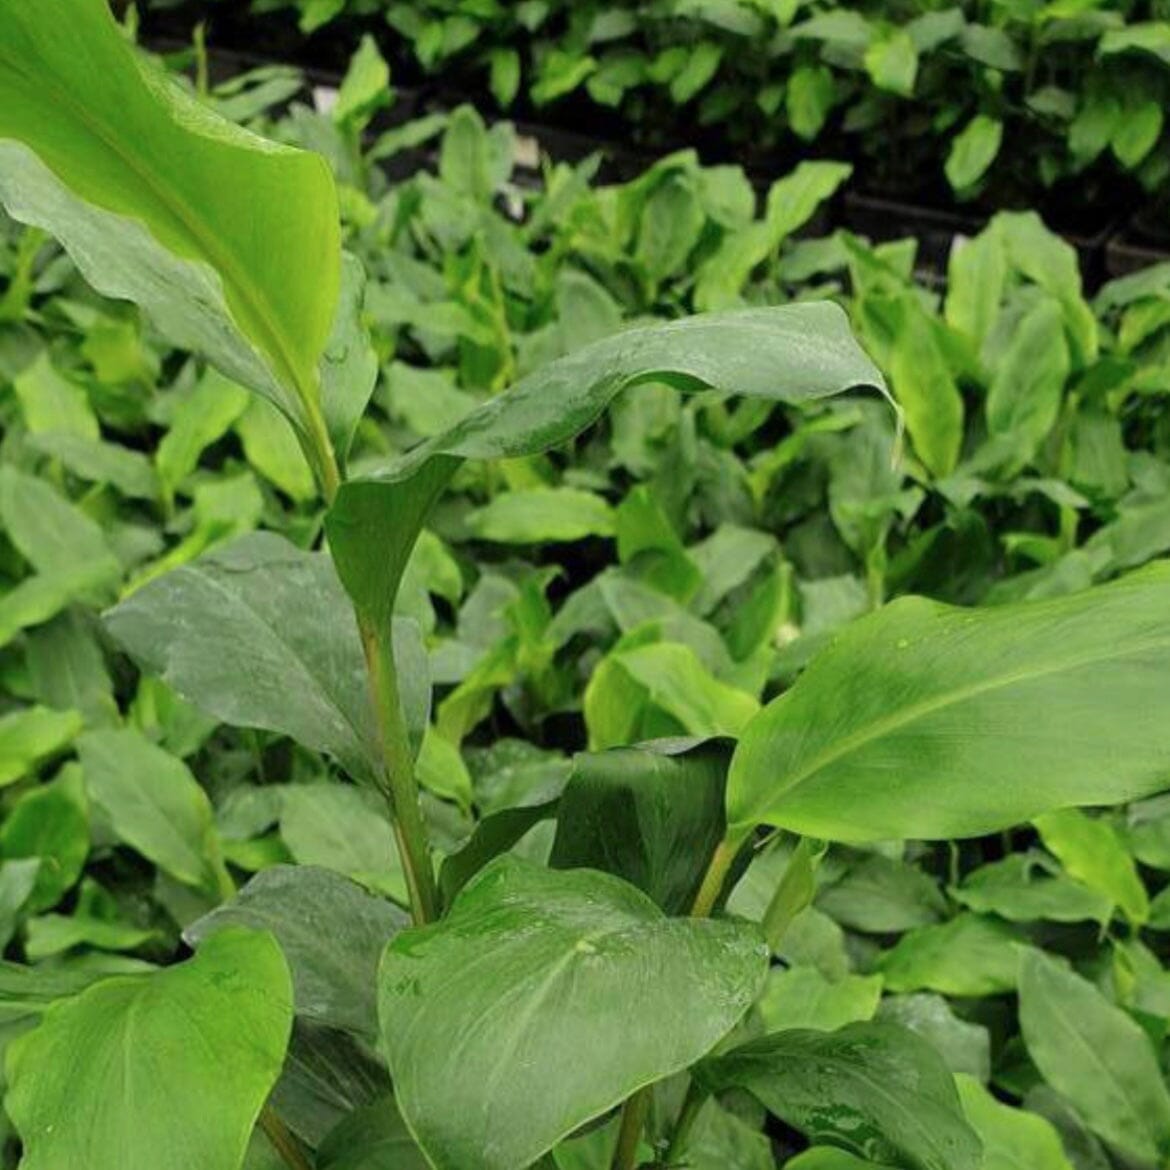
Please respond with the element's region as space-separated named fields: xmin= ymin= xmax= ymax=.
xmin=184 ymin=866 xmax=408 ymax=1039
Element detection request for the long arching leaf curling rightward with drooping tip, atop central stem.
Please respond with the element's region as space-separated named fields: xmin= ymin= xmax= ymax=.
xmin=326 ymin=303 xmax=883 ymax=650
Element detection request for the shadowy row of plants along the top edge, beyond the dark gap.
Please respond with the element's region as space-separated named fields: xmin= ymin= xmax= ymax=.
xmin=134 ymin=0 xmax=1170 ymax=218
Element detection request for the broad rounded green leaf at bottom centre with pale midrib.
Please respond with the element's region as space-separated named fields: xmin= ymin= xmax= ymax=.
xmin=379 ymin=858 xmax=766 ymax=1170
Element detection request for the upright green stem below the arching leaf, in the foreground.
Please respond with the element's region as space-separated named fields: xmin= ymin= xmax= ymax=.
xmin=362 ymin=627 xmax=439 ymax=925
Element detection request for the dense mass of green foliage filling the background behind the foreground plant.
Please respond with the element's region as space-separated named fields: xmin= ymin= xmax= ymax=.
xmin=0 ymin=9 xmax=1170 ymax=1170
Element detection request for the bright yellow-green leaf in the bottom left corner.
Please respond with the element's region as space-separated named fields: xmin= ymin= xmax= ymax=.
xmin=6 ymin=931 xmax=293 ymax=1170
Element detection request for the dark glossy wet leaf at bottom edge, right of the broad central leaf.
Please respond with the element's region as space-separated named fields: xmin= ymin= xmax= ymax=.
xmin=698 ymin=1024 xmax=980 ymax=1170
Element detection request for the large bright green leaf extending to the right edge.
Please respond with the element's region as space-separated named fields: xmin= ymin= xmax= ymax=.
xmin=728 ymin=565 xmax=1170 ymax=841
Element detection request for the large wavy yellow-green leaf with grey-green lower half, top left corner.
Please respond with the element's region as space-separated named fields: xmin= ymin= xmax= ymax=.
xmin=0 ymin=0 xmax=340 ymax=449
